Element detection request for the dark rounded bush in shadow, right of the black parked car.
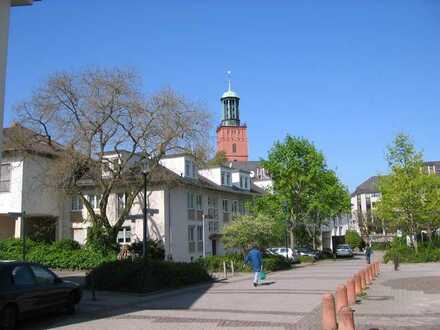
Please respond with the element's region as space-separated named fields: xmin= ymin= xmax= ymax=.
xmin=86 ymin=259 xmax=211 ymax=293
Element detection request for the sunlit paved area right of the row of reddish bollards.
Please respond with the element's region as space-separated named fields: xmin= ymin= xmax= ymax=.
xmin=354 ymin=263 xmax=440 ymax=330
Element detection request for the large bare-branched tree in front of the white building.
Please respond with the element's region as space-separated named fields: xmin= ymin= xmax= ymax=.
xmin=17 ymin=69 xmax=210 ymax=242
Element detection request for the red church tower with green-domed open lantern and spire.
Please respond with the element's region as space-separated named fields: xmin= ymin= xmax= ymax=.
xmin=217 ymin=72 xmax=248 ymax=161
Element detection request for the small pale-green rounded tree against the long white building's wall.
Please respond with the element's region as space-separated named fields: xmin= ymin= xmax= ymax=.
xmin=223 ymin=214 xmax=278 ymax=253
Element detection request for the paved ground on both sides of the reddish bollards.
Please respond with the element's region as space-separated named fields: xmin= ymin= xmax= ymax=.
xmin=22 ymin=255 xmax=440 ymax=330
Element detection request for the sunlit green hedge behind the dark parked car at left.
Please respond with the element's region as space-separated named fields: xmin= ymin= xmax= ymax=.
xmin=0 ymin=239 xmax=116 ymax=270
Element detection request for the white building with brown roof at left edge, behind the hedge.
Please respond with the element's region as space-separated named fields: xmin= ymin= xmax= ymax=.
xmin=0 ymin=125 xmax=66 ymax=239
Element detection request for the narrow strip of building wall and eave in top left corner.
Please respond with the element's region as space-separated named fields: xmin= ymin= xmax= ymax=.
xmin=0 ymin=0 xmax=39 ymax=159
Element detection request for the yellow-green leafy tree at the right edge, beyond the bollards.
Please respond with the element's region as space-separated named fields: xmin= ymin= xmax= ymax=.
xmin=376 ymin=134 xmax=440 ymax=253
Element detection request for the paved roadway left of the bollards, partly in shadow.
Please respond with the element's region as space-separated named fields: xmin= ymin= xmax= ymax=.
xmin=23 ymin=257 xmax=365 ymax=330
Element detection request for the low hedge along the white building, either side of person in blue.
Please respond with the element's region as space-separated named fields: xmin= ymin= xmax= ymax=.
xmin=197 ymin=254 xmax=291 ymax=272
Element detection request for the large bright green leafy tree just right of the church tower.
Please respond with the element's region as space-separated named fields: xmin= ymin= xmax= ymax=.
xmin=263 ymin=135 xmax=350 ymax=247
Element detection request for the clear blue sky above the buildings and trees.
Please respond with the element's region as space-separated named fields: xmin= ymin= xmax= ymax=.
xmin=6 ymin=0 xmax=440 ymax=190
